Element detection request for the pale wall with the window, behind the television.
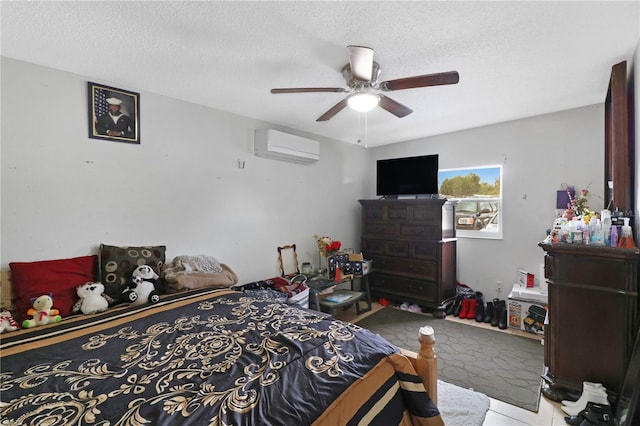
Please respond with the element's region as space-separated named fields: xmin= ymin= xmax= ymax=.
xmin=367 ymin=105 xmax=606 ymax=299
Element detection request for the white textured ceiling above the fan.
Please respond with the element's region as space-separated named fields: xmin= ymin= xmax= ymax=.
xmin=0 ymin=1 xmax=640 ymax=146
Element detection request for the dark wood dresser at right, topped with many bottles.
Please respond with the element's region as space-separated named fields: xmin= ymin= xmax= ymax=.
xmin=539 ymin=243 xmax=640 ymax=394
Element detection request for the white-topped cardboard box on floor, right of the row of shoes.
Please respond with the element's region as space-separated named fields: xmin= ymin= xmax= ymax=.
xmin=507 ymin=284 xmax=548 ymax=335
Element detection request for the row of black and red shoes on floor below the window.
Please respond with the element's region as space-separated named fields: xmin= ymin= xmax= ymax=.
xmin=438 ymin=291 xmax=508 ymax=330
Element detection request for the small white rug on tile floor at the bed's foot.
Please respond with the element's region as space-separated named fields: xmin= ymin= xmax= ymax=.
xmin=438 ymin=380 xmax=491 ymax=426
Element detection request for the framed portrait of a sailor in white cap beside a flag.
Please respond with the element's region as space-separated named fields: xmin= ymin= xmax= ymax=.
xmin=88 ymin=82 xmax=140 ymax=144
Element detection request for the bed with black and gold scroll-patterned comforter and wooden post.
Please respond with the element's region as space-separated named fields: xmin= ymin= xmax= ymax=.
xmin=0 ymin=289 xmax=443 ymax=426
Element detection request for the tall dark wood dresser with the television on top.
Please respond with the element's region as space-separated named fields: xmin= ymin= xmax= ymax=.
xmin=360 ymin=199 xmax=456 ymax=308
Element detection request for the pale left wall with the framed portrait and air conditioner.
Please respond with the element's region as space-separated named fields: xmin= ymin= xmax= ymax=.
xmin=1 ymin=57 xmax=370 ymax=282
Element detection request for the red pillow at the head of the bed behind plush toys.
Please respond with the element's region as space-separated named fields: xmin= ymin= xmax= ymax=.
xmin=9 ymin=256 xmax=97 ymax=323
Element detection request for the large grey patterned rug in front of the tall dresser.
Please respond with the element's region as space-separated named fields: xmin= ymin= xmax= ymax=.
xmin=357 ymin=308 xmax=544 ymax=412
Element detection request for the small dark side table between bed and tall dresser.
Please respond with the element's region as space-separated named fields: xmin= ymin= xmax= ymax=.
xmin=306 ymin=275 xmax=371 ymax=315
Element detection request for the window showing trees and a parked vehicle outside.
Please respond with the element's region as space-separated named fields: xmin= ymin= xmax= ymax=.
xmin=438 ymin=166 xmax=503 ymax=238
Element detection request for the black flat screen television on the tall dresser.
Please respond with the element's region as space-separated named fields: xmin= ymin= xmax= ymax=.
xmin=376 ymin=154 xmax=438 ymax=197
